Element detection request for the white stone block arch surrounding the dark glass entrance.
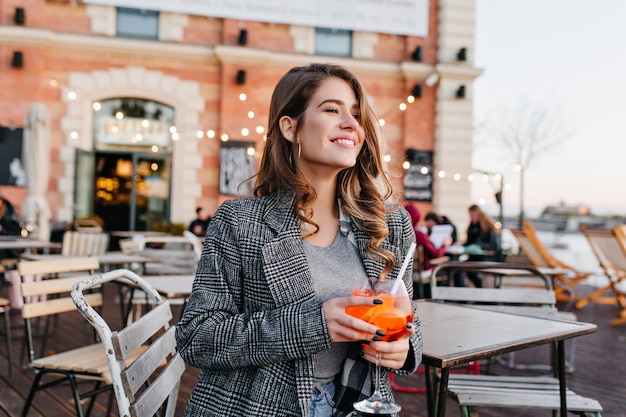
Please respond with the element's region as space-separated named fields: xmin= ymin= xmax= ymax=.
xmin=56 ymin=67 xmax=204 ymax=223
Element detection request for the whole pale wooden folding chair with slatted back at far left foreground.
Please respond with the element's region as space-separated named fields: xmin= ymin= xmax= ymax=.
xmin=17 ymin=257 xmax=106 ymax=417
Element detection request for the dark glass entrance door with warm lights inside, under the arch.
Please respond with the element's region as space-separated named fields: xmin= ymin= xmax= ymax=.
xmin=93 ymin=152 xmax=171 ymax=231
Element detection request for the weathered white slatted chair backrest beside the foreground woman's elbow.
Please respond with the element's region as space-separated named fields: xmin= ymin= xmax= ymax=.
xmin=72 ymin=269 xmax=185 ymax=417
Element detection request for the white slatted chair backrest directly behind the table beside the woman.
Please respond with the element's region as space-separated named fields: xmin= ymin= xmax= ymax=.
xmin=430 ymin=262 xmax=556 ymax=316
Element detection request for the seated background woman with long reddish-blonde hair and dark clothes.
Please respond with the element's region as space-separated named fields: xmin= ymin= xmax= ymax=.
xmin=465 ymin=204 xmax=500 ymax=288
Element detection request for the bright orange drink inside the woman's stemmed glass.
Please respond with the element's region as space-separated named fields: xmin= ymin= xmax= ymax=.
xmin=346 ymin=290 xmax=413 ymax=342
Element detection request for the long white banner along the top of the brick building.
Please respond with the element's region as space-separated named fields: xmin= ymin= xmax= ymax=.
xmin=83 ymin=0 xmax=428 ymax=36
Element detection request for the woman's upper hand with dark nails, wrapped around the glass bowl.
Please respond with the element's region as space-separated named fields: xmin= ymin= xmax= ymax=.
xmin=322 ymin=296 xmax=384 ymax=343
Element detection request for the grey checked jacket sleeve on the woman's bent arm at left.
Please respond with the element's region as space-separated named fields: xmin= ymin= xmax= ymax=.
xmin=176 ymin=202 xmax=330 ymax=371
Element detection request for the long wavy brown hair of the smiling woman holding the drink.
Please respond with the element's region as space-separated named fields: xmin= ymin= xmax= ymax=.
xmin=254 ymin=64 xmax=395 ymax=277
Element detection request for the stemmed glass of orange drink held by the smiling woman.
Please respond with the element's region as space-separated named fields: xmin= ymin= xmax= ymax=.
xmin=346 ymin=279 xmax=413 ymax=414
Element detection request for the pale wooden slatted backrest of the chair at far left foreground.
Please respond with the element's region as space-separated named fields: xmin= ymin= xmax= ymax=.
xmin=17 ymin=257 xmax=102 ymax=362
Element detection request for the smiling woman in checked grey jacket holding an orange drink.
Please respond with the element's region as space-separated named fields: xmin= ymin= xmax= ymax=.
xmin=176 ymin=64 xmax=422 ymax=417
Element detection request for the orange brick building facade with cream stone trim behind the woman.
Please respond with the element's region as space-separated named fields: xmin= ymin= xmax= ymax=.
xmin=0 ymin=0 xmax=481 ymax=234
